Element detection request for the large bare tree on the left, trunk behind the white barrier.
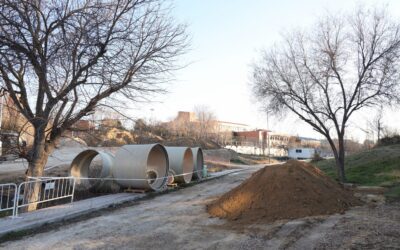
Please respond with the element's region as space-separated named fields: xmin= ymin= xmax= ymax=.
xmin=0 ymin=0 xmax=187 ymax=208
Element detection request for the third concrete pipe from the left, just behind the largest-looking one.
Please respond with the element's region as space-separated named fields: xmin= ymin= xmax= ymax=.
xmin=165 ymin=147 xmax=194 ymax=183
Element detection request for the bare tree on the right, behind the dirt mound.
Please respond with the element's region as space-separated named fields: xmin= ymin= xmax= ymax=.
xmin=252 ymin=5 xmax=400 ymax=182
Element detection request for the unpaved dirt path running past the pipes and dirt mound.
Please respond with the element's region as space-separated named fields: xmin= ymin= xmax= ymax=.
xmin=1 ymin=170 xmax=400 ymax=250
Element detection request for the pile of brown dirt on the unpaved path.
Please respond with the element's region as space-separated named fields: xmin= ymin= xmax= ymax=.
xmin=207 ymin=161 xmax=361 ymax=223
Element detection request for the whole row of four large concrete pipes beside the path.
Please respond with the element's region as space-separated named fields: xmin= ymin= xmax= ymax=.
xmin=70 ymin=144 xmax=203 ymax=191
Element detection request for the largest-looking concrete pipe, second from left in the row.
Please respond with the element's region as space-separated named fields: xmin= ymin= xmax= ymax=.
xmin=113 ymin=144 xmax=169 ymax=191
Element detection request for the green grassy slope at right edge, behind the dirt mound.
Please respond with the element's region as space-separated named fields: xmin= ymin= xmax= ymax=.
xmin=315 ymin=144 xmax=400 ymax=197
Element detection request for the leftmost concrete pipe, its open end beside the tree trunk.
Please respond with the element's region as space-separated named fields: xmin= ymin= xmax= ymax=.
xmin=70 ymin=149 xmax=114 ymax=190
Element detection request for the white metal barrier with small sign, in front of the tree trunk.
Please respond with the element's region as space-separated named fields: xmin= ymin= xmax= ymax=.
xmin=15 ymin=177 xmax=75 ymax=216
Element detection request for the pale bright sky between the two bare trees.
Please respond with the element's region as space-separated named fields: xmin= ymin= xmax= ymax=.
xmin=132 ymin=0 xmax=400 ymax=141
